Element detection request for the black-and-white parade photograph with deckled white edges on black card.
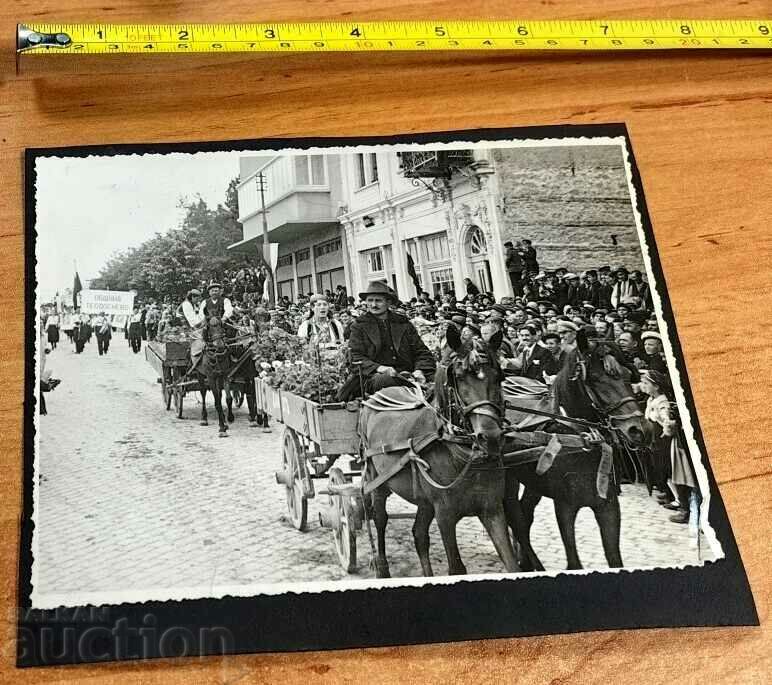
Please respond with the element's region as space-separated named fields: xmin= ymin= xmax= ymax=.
xmin=27 ymin=129 xmax=724 ymax=609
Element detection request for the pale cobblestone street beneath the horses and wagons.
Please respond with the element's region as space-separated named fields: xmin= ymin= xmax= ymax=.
xmin=35 ymin=334 xmax=698 ymax=598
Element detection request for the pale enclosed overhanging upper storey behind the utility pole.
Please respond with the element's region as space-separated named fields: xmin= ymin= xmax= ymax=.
xmin=229 ymin=155 xmax=338 ymax=251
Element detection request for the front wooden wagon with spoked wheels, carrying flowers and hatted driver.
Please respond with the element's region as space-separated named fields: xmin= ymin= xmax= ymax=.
xmin=255 ymin=378 xmax=364 ymax=573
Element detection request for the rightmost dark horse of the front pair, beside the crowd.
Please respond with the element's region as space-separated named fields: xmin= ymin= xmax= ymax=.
xmin=505 ymin=336 xmax=645 ymax=570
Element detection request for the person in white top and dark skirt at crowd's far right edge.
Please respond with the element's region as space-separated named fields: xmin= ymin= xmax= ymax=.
xmin=639 ymin=370 xmax=699 ymax=523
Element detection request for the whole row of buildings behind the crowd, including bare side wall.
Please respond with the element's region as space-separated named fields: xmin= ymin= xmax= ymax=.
xmin=231 ymin=145 xmax=642 ymax=299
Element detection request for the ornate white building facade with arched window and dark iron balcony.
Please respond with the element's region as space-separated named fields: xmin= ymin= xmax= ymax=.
xmin=340 ymin=150 xmax=508 ymax=299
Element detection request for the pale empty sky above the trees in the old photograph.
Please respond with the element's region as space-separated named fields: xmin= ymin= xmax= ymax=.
xmin=36 ymin=152 xmax=240 ymax=301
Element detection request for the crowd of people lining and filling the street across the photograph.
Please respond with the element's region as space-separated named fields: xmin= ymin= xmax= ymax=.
xmin=37 ymin=240 xmax=699 ymax=523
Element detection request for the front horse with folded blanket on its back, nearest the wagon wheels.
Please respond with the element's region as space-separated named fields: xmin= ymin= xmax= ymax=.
xmin=359 ymin=326 xmax=520 ymax=578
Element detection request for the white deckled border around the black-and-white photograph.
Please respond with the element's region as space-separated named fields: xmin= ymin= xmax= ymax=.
xmin=25 ymin=130 xmax=724 ymax=609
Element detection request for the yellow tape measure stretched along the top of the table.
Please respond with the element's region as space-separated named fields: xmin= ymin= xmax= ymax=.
xmin=17 ymin=19 xmax=772 ymax=55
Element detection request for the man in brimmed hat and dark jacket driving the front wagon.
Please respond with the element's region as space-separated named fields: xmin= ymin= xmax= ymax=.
xmin=338 ymin=281 xmax=436 ymax=400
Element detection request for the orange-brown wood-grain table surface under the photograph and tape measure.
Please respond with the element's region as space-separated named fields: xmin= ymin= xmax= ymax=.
xmin=0 ymin=0 xmax=772 ymax=685
